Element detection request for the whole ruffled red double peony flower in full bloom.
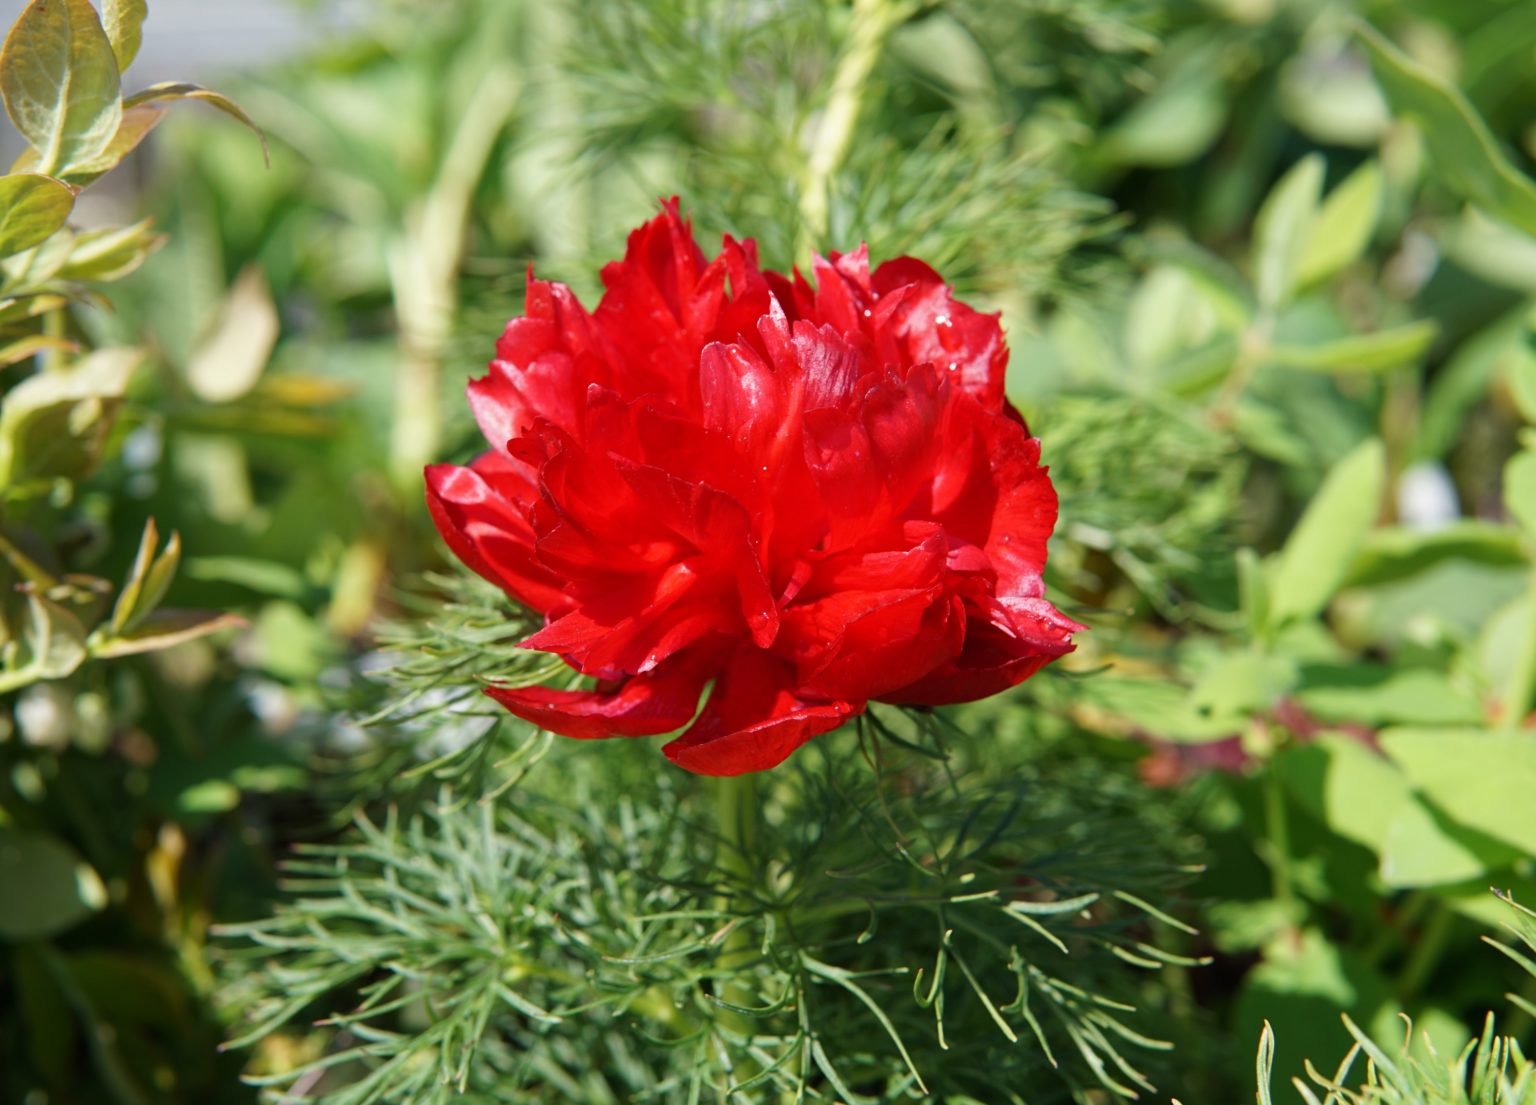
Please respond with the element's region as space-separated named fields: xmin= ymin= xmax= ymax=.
xmin=427 ymin=200 xmax=1083 ymax=775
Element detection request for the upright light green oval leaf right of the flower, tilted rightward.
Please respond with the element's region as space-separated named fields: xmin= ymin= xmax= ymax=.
xmin=1270 ymin=438 xmax=1387 ymax=624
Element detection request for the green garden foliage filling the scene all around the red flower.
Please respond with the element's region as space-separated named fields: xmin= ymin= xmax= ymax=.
xmin=0 ymin=0 xmax=1536 ymax=1105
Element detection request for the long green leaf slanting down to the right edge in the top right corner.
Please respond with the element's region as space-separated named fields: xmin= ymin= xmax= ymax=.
xmin=1356 ymin=25 xmax=1536 ymax=235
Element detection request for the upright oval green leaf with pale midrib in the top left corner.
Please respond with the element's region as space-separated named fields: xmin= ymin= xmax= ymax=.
xmin=0 ymin=0 xmax=123 ymax=175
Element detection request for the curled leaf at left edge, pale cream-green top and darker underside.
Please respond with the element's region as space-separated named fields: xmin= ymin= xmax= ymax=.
xmin=0 ymin=349 xmax=141 ymax=493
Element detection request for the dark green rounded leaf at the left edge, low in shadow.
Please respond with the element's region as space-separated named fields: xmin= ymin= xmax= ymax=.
xmin=0 ymin=833 xmax=106 ymax=942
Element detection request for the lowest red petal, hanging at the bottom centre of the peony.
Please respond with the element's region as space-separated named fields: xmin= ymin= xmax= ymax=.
xmin=662 ymin=647 xmax=863 ymax=775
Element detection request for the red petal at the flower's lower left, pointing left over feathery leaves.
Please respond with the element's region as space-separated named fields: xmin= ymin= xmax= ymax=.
xmin=485 ymin=658 xmax=708 ymax=739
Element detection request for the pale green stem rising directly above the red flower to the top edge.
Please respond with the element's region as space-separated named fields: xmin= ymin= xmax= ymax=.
xmin=797 ymin=0 xmax=906 ymax=258
